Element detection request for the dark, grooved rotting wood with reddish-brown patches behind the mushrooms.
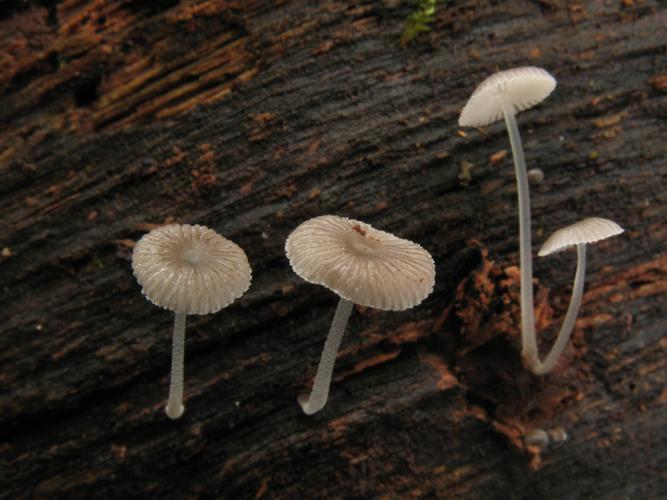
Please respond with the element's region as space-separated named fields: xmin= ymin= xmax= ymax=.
xmin=0 ymin=0 xmax=667 ymax=499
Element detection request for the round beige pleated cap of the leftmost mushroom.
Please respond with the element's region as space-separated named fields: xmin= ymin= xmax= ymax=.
xmin=132 ymin=224 xmax=252 ymax=314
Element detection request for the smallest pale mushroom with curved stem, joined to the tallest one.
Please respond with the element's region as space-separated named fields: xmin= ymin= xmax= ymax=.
xmin=527 ymin=217 xmax=623 ymax=375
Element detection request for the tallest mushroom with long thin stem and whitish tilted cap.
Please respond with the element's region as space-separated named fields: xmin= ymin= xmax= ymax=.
xmin=459 ymin=67 xmax=556 ymax=370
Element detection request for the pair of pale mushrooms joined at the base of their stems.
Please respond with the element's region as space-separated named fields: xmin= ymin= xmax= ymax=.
xmin=459 ymin=67 xmax=623 ymax=375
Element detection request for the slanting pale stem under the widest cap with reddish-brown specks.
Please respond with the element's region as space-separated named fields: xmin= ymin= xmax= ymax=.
xmin=298 ymin=297 xmax=354 ymax=415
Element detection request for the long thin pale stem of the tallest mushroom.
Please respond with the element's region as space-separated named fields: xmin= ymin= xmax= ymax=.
xmin=500 ymin=96 xmax=539 ymax=367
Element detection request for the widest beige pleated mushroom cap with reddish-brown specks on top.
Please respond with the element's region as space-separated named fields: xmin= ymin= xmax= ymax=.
xmin=285 ymin=215 xmax=435 ymax=311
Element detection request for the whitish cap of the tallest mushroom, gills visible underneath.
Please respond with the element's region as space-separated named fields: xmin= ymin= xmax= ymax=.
xmin=459 ymin=66 xmax=556 ymax=127
